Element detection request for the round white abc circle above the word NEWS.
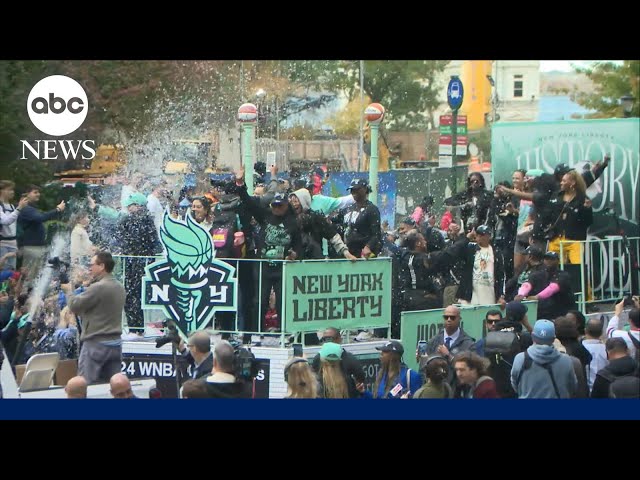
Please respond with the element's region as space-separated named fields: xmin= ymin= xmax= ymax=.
xmin=27 ymin=75 xmax=89 ymax=137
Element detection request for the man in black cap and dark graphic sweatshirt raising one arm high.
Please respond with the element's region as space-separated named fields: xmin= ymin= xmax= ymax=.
xmin=236 ymin=168 xmax=303 ymax=327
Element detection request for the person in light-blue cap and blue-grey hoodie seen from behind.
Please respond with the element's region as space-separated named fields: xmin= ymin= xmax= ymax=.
xmin=511 ymin=319 xmax=578 ymax=398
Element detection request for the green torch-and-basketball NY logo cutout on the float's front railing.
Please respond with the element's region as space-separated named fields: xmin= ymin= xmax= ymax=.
xmin=142 ymin=213 xmax=236 ymax=334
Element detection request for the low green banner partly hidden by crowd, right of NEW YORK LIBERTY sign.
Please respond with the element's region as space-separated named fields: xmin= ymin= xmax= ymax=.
xmin=400 ymin=302 xmax=538 ymax=370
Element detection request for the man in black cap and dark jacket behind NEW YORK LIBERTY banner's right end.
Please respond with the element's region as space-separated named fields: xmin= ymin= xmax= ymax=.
xmin=343 ymin=178 xmax=382 ymax=258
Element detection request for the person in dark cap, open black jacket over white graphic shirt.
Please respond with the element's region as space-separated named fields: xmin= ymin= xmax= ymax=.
xmin=458 ymin=225 xmax=504 ymax=305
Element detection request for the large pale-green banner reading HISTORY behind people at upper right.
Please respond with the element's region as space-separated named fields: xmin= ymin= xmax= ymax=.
xmin=491 ymin=118 xmax=640 ymax=236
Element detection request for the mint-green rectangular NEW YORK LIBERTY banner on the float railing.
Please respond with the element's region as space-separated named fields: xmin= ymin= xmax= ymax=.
xmin=282 ymin=258 xmax=391 ymax=333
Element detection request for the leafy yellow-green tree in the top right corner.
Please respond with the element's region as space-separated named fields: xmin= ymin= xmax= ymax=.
xmin=575 ymin=60 xmax=640 ymax=118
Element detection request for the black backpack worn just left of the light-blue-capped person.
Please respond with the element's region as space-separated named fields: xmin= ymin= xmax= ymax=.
xmin=484 ymin=331 xmax=521 ymax=398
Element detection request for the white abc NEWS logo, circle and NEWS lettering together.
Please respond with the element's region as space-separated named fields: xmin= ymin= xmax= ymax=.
xmin=21 ymin=75 xmax=96 ymax=160
